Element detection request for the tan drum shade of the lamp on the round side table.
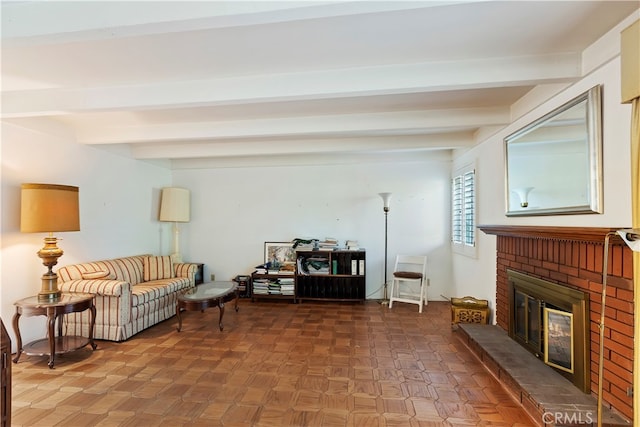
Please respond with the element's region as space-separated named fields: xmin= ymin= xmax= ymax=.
xmin=20 ymin=184 xmax=80 ymax=233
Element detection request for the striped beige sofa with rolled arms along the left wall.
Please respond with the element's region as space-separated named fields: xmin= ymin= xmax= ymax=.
xmin=57 ymin=255 xmax=197 ymax=341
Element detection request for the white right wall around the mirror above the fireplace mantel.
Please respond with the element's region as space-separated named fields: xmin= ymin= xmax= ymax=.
xmin=453 ymin=58 xmax=631 ymax=316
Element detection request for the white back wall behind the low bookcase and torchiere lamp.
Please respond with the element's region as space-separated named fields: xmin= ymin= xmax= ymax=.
xmin=174 ymin=154 xmax=451 ymax=299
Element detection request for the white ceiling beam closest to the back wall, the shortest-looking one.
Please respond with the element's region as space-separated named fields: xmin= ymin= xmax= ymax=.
xmin=131 ymin=132 xmax=474 ymax=159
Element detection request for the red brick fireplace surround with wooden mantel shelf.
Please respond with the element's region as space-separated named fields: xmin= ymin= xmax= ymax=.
xmin=479 ymin=225 xmax=633 ymax=420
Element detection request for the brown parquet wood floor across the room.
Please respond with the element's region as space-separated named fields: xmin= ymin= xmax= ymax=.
xmin=12 ymin=300 xmax=534 ymax=427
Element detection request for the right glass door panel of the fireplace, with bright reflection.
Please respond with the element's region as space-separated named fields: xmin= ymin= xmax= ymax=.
xmin=544 ymin=307 xmax=574 ymax=373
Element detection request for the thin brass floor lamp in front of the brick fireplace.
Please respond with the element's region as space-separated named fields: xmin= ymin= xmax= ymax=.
xmin=597 ymin=229 xmax=640 ymax=427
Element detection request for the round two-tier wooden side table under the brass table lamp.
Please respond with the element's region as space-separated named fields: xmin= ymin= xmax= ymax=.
xmin=13 ymin=293 xmax=97 ymax=369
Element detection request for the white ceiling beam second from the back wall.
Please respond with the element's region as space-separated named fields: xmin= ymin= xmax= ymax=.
xmin=77 ymin=107 xmax=510 ymax=144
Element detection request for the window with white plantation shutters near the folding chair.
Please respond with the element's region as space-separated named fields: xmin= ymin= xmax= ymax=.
xmin=451 ymin=169 xmax=476 ymax=252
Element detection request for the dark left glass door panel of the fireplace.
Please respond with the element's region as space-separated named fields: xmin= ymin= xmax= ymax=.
xmin=514 ymin=291 xmax=543 ymax=357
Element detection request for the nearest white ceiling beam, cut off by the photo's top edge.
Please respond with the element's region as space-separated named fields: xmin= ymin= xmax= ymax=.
xmin=1 ymin=0 xmax=476 ymax=45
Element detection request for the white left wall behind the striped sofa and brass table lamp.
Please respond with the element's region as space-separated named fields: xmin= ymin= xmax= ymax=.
xmin=0 ymin=122 xmax=171 ymax=351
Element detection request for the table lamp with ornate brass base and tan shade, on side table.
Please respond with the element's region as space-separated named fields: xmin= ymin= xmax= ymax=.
xmin=20 ymin=184 xmax=80 ymax=301
